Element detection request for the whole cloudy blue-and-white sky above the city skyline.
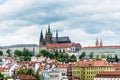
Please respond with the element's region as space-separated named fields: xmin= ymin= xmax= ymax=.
xmin=0 ymin=0 xmax=120 ymax=46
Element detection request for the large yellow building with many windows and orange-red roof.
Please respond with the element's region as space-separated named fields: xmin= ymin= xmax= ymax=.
xmin=72 ymin=60 xmax=115 ymax=80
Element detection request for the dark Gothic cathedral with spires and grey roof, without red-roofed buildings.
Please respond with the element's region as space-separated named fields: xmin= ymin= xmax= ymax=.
xmin=39 ymin=25 xmax=71 ymax=47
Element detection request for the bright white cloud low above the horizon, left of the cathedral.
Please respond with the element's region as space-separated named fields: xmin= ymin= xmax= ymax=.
xmin=0 ymin=26 xmax=40 ymax=45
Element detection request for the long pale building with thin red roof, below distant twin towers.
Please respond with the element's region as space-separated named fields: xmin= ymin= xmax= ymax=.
xmin=80 ymin=46 xmax=120 ymax=58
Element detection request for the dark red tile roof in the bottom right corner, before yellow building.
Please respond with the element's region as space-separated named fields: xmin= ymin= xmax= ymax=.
xmin=95 ymin=71 xmax=120 ymax=78
